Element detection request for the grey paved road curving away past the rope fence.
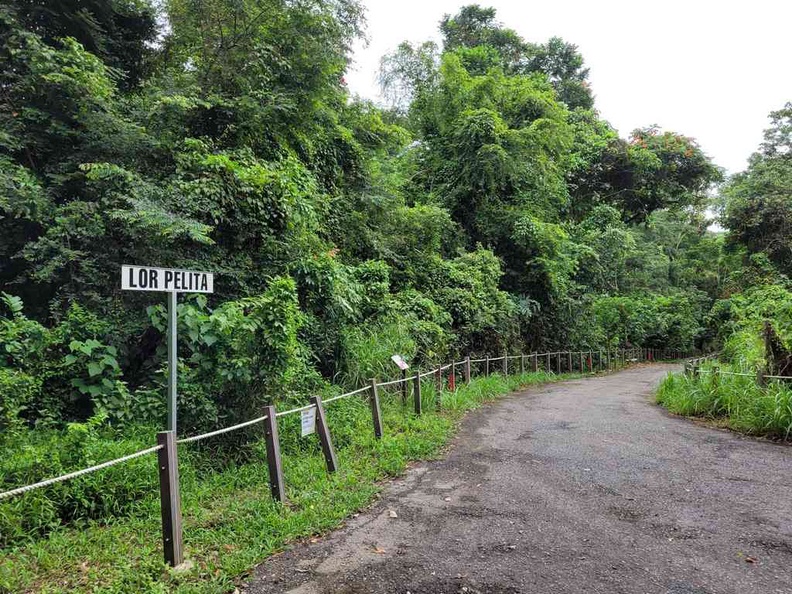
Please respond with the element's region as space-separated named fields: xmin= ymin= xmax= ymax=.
xmin=246 ymin=365 xmax=792 ymax=594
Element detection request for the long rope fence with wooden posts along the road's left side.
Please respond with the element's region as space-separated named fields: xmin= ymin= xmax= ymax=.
xmin=0 ymin=349 xmax=688 ymax=566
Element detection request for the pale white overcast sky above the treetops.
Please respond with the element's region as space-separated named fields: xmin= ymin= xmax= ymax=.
xmin=346 ymin=0 xmax=792 ymax=173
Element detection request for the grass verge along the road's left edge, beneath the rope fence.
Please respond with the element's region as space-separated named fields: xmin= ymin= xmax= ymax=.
xmin=0 ymin=372 xmax=578 ymax=594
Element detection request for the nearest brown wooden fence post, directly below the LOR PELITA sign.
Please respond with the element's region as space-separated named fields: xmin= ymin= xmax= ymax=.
xmin=157 ymin=431 xmax=184 ymax=567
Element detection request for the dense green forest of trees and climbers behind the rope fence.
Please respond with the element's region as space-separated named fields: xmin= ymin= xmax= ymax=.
xmin=0 ymin=0 xmax=792 ymax=556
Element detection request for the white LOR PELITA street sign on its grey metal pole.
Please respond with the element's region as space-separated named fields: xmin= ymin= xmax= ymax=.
xmin=121 ymin=264 xmax=214 ymax=435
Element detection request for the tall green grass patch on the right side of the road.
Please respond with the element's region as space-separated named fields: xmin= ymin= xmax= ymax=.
xmin=657 ymin=366 xmax=792 ymax=434
